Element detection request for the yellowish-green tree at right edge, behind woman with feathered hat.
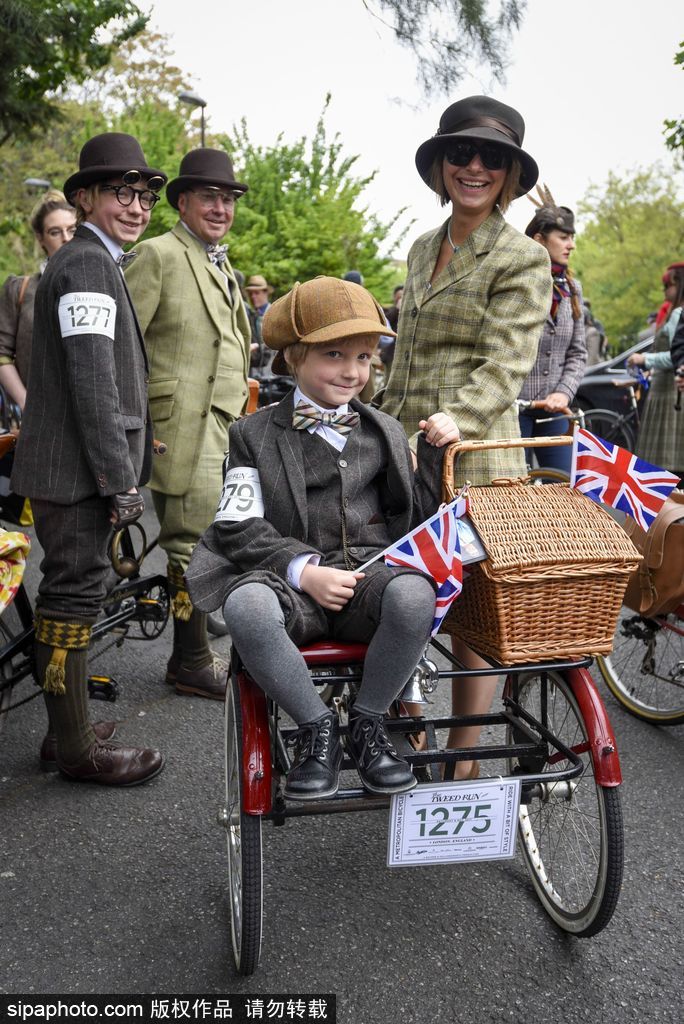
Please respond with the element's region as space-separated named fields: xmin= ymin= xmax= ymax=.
xmin=573 ymin=165 xmax=684 ymax=351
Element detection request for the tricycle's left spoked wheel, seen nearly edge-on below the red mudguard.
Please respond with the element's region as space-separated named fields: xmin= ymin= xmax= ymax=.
xmin=223 ymin=675 xmax=263 ymax=975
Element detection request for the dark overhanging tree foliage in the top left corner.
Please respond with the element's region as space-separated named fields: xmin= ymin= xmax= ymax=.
xmin=0 ymin=0 xmax=147 ymax=145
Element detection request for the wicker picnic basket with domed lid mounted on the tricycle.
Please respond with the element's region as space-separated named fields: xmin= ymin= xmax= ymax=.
xmin=442 ymin=438 xmax=640 ymax=665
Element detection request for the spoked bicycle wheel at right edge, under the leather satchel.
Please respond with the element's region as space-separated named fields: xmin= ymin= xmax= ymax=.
xmin=596 ymin=606 xmax=684 ymax=725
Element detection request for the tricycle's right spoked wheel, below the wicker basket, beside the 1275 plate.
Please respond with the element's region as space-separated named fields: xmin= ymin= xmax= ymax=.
xmin=509 ymin=672 xmax=623 ymax=936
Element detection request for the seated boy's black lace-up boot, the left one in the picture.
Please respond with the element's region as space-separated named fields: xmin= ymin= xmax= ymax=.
xmin=285 ymin=712 xmax=344 ymax=800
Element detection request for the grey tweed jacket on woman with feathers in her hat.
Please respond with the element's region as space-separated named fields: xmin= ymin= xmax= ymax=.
xmin=520 ymin=281 xmax=587 ymax=401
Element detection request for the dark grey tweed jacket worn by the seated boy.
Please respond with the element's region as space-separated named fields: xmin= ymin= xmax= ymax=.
xmin=185 ymin=392 xmax=443 ymax=611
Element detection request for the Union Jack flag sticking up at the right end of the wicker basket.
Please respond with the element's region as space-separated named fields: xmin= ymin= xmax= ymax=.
xmin=570 ymin=427 xmax=679 ymax=529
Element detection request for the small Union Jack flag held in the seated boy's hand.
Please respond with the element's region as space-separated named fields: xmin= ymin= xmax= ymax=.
xmin=383 ymin=498 xmax=468 ymax=636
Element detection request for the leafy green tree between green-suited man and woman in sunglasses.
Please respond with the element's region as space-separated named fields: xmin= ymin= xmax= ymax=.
xmin=217 ymin=96 xmax=411 ymax=297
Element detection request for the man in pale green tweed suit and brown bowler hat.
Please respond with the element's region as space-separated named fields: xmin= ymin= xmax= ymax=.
xmin=126 ymin=148 xmax=251 ymax=700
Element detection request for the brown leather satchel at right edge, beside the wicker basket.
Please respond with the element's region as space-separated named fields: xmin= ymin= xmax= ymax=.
xmin=624 ymin=490 xmax=684 ymax=617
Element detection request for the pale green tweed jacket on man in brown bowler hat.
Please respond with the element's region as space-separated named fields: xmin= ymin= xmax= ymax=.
xmin=126 ymin=223 xmax=251 ymax=497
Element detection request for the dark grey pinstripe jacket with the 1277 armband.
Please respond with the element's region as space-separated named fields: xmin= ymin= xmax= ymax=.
xmin=11 ymin=226 xmax=152 ymax=505
